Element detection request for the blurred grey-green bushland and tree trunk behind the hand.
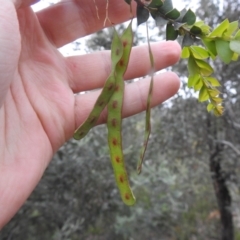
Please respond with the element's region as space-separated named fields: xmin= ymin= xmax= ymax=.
xmin=0 ymin=0 xmax=240 ymax=240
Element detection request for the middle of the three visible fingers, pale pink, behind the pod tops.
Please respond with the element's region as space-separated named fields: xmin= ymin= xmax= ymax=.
xmin=66 ymin=41 xmax=181 ymax=93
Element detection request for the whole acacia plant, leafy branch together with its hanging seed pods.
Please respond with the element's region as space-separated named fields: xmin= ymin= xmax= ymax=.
xmin=74 ymin=0 xmax=240 ymax=205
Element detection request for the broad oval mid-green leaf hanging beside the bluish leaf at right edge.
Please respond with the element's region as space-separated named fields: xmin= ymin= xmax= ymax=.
xmin=216 ymin=39 xmax=233 ymax=64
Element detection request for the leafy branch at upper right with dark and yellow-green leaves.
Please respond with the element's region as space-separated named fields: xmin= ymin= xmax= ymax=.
xmin=125 ymin=0 xmax=240 ymax=116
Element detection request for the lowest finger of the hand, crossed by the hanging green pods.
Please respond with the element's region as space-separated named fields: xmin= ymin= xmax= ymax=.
xmin=75 ymin=72 xmax=180 ymax=128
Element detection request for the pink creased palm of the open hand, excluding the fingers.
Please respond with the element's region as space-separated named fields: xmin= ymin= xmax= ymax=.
xmin=0 ymin=4 xmax=75 ymax=227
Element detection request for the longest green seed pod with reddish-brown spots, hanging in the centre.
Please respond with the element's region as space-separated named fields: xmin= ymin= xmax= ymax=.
xmin=107 ymin=23 xmax=136 ymax=205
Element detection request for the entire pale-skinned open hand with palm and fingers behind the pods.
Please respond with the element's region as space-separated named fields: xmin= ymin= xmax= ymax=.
xmin=0 ymin=0 xmax=181 ymax=229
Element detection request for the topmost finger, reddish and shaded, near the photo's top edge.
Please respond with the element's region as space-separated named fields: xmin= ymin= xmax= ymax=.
xmin=37 ymin=0 xmax=135 ymax=47
